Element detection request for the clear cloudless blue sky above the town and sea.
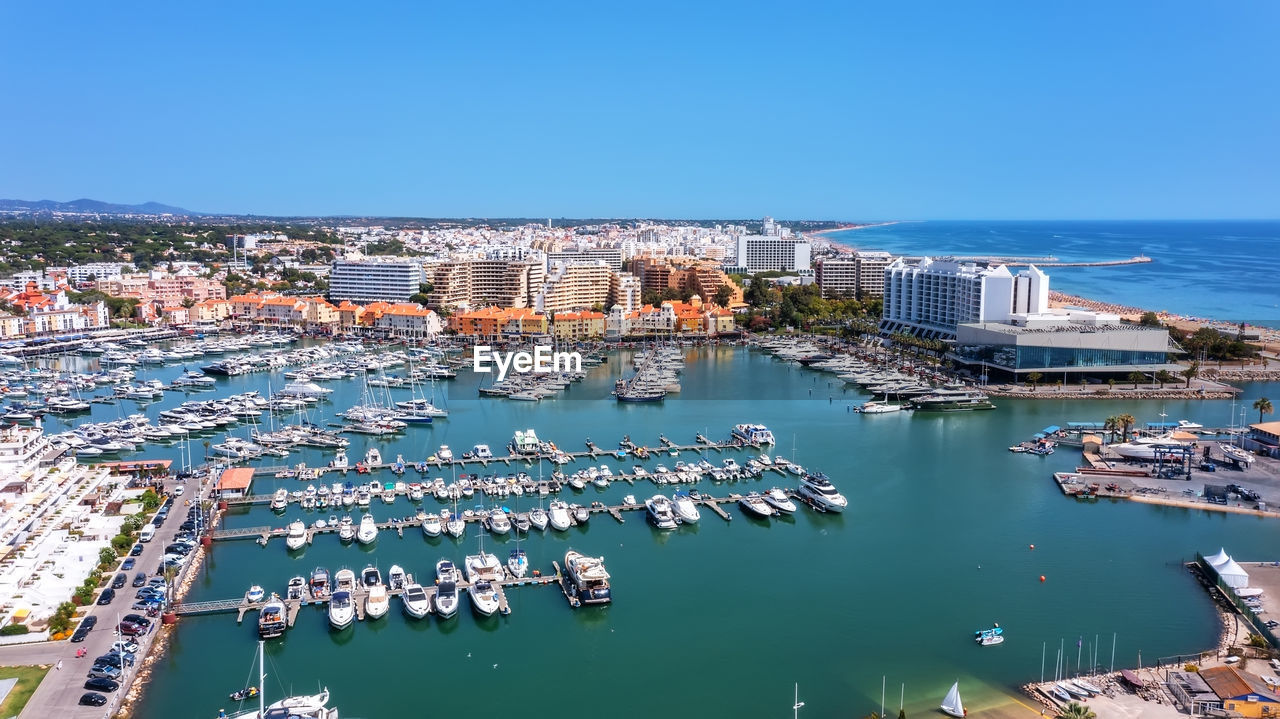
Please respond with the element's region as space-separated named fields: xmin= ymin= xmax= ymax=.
xmin=0 ymin=0 xmax=1280 ymax=220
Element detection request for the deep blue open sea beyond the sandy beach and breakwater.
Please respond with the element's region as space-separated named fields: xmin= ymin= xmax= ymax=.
xmin=827 ymin=220 xmax=1280 ymax=326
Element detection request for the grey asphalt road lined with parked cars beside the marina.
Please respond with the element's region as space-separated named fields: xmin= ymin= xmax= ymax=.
xmin=0 ymin=470 xmax=212 ymax=719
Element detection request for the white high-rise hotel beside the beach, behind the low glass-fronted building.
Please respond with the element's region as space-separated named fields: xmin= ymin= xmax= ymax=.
xmin=881 ymin=257 xmax=1048 ymax=339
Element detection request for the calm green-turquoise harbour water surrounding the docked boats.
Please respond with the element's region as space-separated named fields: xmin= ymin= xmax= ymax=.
xmin=55 ymin=348 xmax=1280 ymax=719
